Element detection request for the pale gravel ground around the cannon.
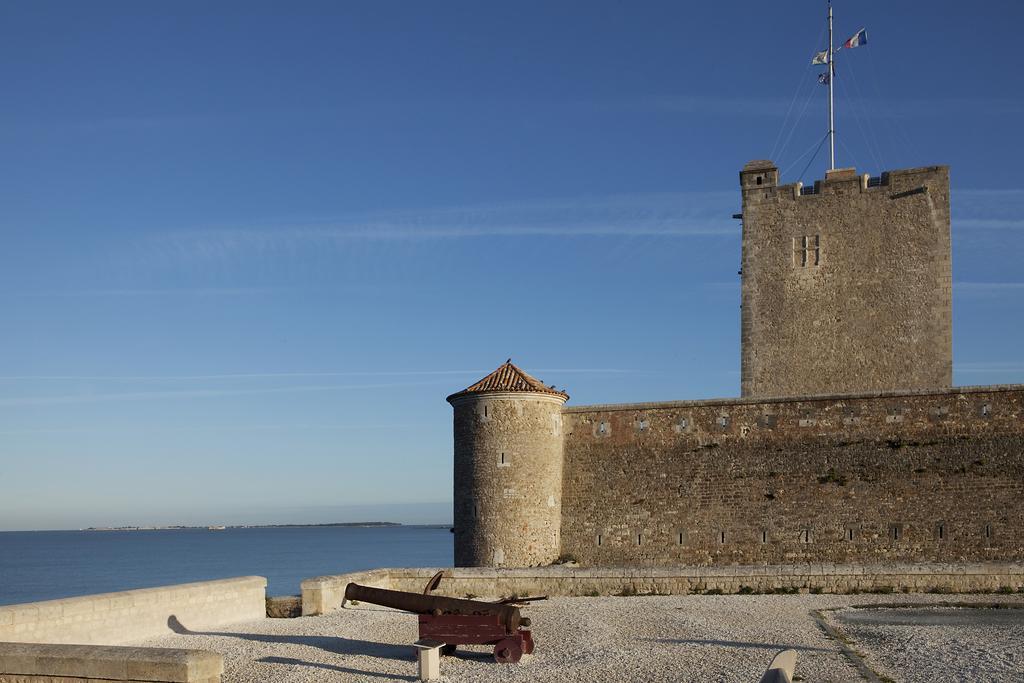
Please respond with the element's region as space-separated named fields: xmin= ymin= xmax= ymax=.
xmin=140 ymin=595 xmax=1024 ymax=683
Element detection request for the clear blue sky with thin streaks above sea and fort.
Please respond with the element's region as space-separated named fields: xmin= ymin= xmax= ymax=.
xmin=0 ymin=0 xmax=1024 ymax=529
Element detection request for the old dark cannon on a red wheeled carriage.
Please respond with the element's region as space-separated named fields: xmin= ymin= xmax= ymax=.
xmin=345 ymin=575 xmax=534 ymax=664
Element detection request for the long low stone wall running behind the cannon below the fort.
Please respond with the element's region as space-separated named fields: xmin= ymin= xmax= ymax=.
xmin=302 ymin=564 xmax=1024 ymax=615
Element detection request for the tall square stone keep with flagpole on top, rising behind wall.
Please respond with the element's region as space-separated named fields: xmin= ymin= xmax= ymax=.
xmin=739 ymin=161 xmax=952 ymax=396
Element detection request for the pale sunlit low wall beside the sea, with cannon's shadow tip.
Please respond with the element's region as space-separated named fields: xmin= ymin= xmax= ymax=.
xmin=0 ymin=577 xmax=266 ymax=645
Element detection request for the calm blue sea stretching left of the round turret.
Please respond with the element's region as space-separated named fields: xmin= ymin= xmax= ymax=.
xmin=0 ymin=525 xmax=453 ymax=605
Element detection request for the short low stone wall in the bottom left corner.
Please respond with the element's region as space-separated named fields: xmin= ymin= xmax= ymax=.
xmin=0 ymin=643 xmax=224 ymax=683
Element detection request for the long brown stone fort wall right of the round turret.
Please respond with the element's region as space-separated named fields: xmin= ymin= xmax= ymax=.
xmin=561 ymin=385 xmax=1024 ymax=566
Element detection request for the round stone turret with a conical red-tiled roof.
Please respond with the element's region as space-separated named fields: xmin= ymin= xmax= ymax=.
xmin=447 ymin=359 xmax=568 ymax=566
